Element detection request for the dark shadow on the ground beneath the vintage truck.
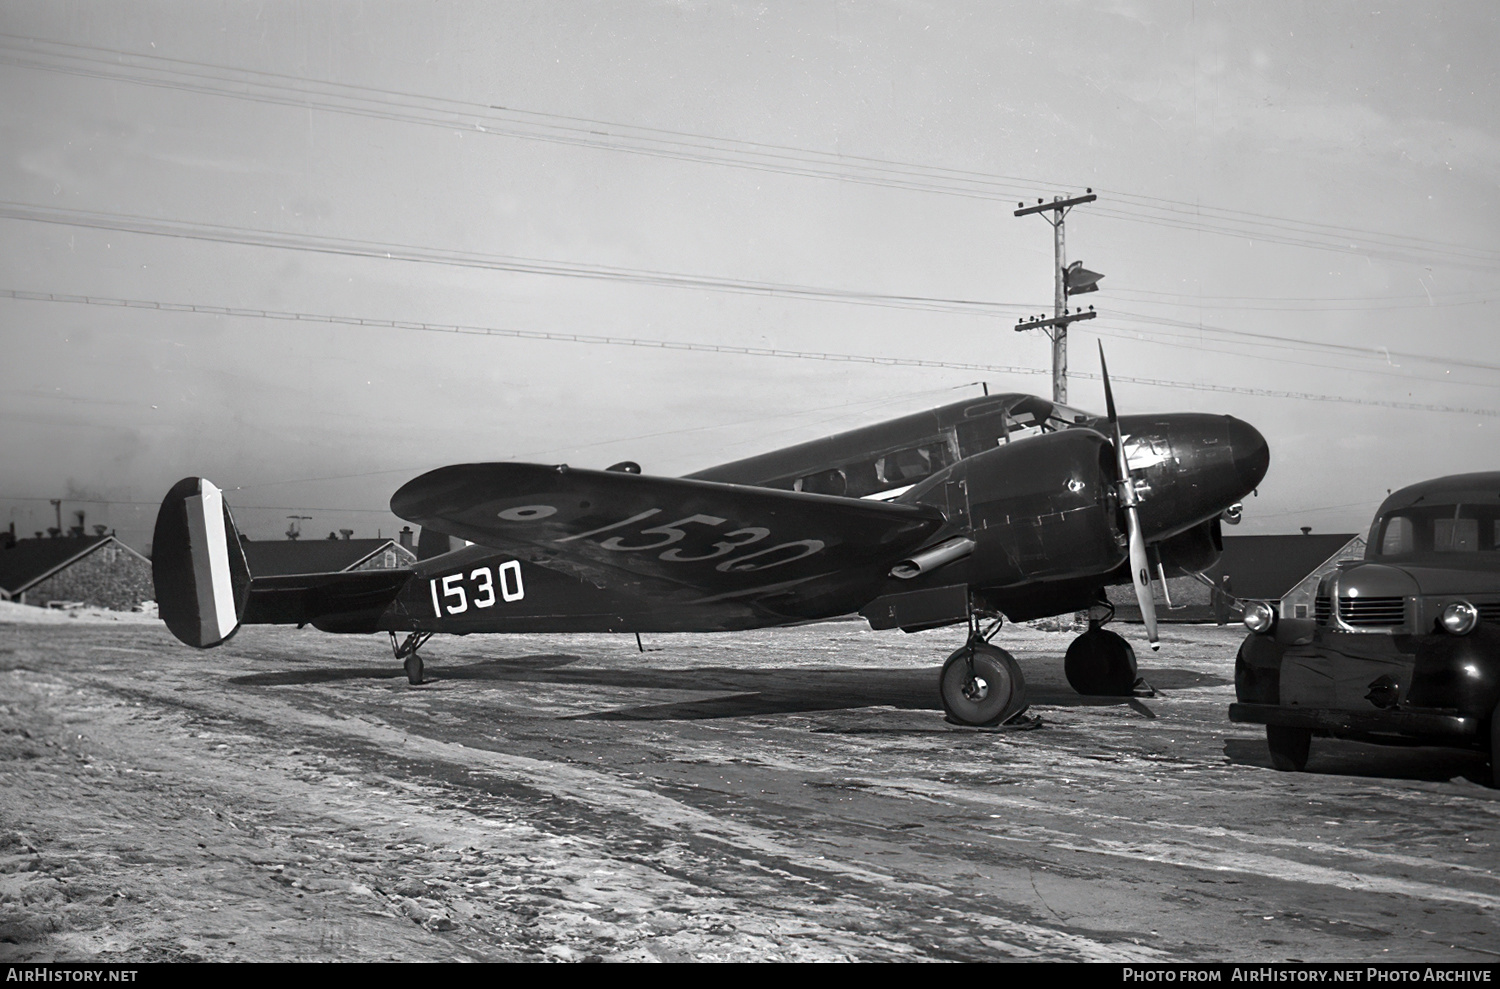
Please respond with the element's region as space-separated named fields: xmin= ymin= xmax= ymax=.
xmin=1224 ymin=734 xmax=1485 ymax=785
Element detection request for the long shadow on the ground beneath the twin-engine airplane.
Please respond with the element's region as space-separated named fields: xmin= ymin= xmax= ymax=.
xmin=231 ymin=654 xmax=1202 ymax=720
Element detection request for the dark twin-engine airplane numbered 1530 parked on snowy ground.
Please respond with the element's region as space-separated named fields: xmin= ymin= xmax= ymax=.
xmin=152 ymin=353 xmax=1269 ymax=725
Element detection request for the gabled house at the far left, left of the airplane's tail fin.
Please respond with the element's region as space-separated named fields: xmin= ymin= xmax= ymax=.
xmin=0 ymin=533 xmax=156 ymax=611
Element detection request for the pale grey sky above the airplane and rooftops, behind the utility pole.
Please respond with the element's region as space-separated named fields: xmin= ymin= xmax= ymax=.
xmin=0 ymin=0 xmax=1500 ymax=549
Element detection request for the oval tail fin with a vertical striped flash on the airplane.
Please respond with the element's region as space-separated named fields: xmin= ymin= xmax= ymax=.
xmin=152 ymin=477 xmax=251 ymax=648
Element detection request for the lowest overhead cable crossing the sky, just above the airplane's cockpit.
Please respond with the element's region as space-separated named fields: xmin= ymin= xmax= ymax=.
xmin=0 ymin=288 xmax=1500 ymax=417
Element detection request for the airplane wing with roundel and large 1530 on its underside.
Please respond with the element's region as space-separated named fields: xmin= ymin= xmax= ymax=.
xmin=390 ymin=464 xmax=944 ymax=615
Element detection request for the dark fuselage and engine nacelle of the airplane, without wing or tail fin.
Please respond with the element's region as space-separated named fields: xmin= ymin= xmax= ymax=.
xmin=351 ymin=395 xmax=1269 ymax=635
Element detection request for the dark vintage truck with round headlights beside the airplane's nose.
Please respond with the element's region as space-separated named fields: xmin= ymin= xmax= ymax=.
xmin=1229 ymin=471 xmax=1500 ymax=786
